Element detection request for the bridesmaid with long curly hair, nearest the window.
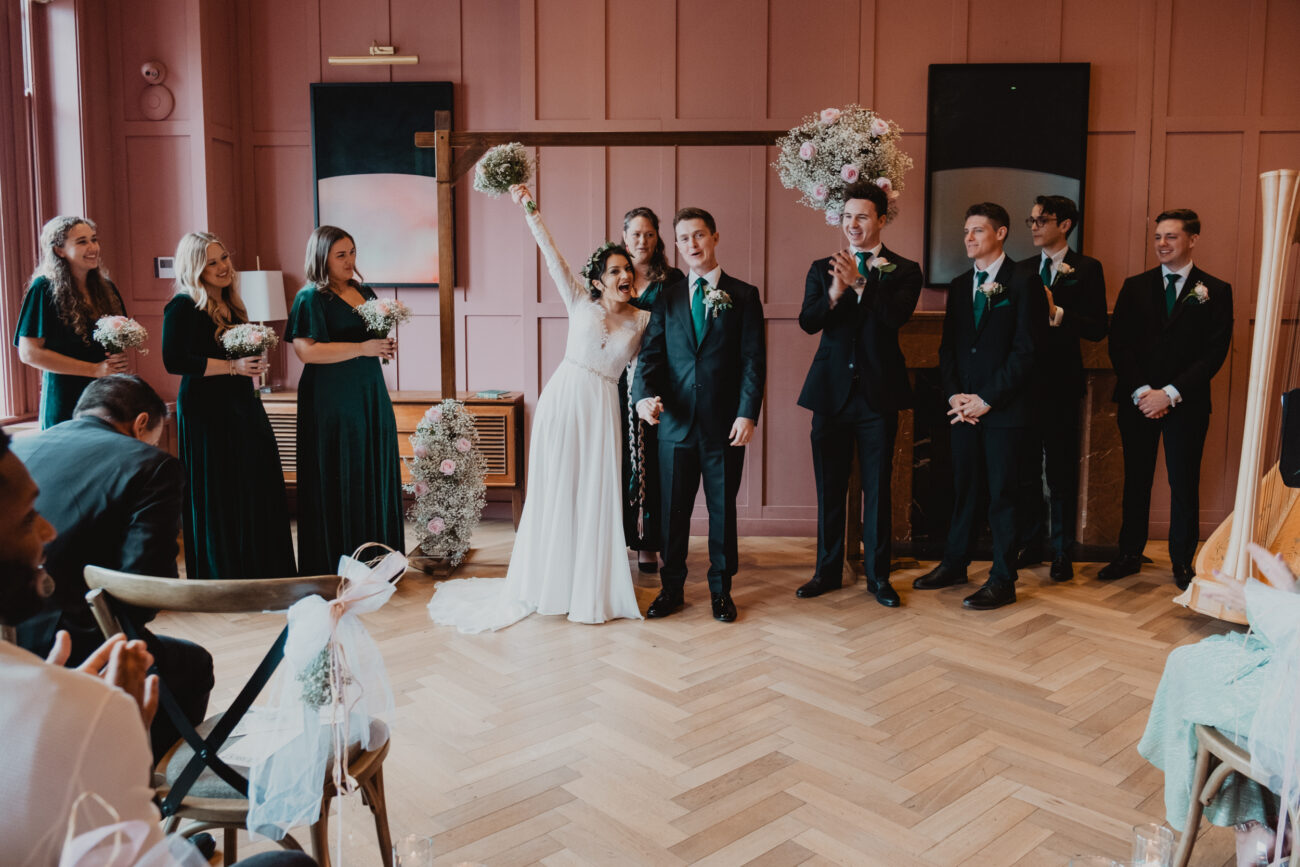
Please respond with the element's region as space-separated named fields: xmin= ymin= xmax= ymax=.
xmin=13 ymin=217 xmax=127 ymax=430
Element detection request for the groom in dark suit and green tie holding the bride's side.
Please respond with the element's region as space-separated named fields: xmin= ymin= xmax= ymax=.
xmin=632 ymin=208 xmax=767 ymax=623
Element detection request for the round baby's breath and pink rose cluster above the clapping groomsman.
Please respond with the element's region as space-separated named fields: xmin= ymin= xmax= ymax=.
xmin=772 ymin=105 xmax=911 ymax=226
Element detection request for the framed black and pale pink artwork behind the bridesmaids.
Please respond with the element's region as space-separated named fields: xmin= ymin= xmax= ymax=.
xmin=311 ymin=82 xmax=451 ymax=287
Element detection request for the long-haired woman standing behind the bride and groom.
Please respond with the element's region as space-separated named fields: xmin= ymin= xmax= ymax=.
xmin=619 ymin=208 xmax=684 ymax=572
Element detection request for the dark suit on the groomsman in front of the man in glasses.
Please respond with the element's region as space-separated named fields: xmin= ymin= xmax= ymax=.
xmin=939 ymin=257 xmax=1048 ymax=582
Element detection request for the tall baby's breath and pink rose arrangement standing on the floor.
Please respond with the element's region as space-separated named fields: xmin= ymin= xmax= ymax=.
xmin=404 ymin=399 xmax=488 ymax=567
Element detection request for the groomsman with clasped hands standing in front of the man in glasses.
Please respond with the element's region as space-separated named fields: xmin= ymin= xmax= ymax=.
xmin=911 ymin=201 xmax=1048 ymax=611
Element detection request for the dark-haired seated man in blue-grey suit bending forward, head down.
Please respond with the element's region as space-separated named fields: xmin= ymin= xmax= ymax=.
xmin=13 ymin=374 xmax=212 ymax=755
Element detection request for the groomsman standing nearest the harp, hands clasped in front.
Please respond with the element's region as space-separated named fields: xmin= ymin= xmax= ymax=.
xmin=1097 ymin=209 xmax=1232 ymax=590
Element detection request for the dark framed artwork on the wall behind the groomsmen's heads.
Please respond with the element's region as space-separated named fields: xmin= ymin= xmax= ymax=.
xmin=926 ymin=64 xmax=1089 ymax=286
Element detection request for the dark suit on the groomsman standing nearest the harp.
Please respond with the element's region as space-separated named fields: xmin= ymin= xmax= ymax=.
xmin=1109 ymin=265 xmax=1232 ymax=565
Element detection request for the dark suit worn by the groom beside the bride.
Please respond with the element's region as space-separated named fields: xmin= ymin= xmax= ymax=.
xmin=632 ymin=273 xmax=767 ymax=595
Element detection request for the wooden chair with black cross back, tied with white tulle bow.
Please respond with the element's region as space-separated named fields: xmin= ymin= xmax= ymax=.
xmin=86 ymin=565 xmax=393 ymax=867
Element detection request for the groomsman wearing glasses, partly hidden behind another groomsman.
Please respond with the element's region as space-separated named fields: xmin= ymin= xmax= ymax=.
xmin=1017 ymin=196 xmax=1106 ymax=581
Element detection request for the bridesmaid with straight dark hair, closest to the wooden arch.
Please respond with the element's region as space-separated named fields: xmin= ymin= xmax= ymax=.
xmin=286 ymin=226 xmax=406 ymax=575
